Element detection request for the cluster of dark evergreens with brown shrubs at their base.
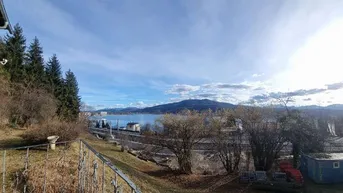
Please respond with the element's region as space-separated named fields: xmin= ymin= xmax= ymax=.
xmin=0 ymin=24 xmax=80 ymax=130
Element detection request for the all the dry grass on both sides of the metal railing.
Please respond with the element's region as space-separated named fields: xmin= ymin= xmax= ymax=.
xmin=0 ymin=129 xmax=240 ymax=193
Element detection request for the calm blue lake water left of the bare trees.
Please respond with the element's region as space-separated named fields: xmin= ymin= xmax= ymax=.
xmin=91 ymin=114 xmax=161 ymax=127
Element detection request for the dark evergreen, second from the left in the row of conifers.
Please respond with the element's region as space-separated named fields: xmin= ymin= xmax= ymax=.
xmin=25 ymin=37 xmax=46 ymax=88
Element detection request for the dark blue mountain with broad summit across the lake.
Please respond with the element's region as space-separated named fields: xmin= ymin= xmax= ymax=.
xmin=138 ymin=99 xmax=236 ymax=113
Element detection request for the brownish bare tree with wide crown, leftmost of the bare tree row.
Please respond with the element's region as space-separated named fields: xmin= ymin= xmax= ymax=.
xmin=157 ymin=111 xmax=206 ymax=174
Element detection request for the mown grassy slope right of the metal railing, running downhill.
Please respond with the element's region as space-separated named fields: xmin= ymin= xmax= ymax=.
xmin=82 ymin=134 xmax=240 ymax=193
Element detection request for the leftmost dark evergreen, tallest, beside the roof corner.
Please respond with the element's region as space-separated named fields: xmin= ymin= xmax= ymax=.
xmin=2 ymin=24 xmax=26 ymax=82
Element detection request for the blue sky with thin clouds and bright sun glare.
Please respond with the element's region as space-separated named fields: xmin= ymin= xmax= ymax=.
xmin=2 ymin=0 xmax=343 ymax=109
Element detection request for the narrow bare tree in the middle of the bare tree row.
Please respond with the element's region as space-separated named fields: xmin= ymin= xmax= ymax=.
xmin=211 ymin=110 xmax=243 ymax=174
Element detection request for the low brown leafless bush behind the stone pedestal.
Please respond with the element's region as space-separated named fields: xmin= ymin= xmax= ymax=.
xmin=22 ymin=120 xmax=84 ymax=144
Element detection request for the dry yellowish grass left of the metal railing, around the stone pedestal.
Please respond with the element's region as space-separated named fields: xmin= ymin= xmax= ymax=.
xmin=0 ymin=129 xmax=78 ymax=193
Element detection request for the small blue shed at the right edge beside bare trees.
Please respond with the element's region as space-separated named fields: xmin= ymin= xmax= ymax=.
xmin=300 ymin=153 xmax=343 ymax=184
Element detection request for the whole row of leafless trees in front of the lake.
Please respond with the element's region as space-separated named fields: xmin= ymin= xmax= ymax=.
xmin=153 ymin=106 xmax=325 ymax=174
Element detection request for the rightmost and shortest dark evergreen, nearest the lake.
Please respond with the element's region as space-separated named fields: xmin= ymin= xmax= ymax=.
xmin=61 ymin=70 xmax=80 ymax=121
